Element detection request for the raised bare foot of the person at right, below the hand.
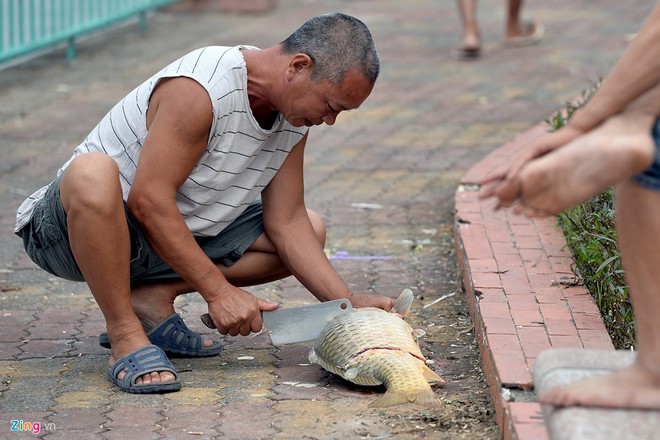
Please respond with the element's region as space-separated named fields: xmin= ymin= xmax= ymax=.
xmin=517 ymin=114 xmax=655 ymax=217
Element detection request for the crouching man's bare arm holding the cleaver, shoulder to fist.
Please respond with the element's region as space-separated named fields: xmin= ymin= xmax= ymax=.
xmin=128 ymin=77 xmax=274 ymax=336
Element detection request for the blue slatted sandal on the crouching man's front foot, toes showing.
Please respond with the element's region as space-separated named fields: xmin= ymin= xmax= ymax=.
xmin=108 ymin=345 xmax=181 ymax=394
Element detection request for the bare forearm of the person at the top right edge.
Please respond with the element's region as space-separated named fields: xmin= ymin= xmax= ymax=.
xmin=571 ymin=3 xmax=660 ymax=132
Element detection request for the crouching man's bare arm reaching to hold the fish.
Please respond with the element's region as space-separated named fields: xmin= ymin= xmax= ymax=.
xmin=262 ymin=135 xmax=393 ymax=310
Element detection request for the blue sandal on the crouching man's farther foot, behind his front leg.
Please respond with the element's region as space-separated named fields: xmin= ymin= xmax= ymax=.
xmin=99 ymin=313 xmax=222 ymax=357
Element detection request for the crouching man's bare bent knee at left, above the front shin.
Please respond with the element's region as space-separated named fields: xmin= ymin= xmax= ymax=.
xmin=60 ymin=153 xmax=122 ymax=212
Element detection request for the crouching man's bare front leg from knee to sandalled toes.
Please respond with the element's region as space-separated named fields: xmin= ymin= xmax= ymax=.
xmin=60 ymin=153 xmax=175 ymax=384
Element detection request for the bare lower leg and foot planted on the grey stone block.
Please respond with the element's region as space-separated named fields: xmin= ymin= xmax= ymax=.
xmin=539 ymin=181 xmax=660 ymax=410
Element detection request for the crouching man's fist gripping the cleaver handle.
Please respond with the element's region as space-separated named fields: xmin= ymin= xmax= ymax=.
xmin=208 ymin=285 xmax=279 ymax=336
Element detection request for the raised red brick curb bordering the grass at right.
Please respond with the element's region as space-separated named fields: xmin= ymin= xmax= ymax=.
xmin=455 ymin=125 xmax=614 ymax=440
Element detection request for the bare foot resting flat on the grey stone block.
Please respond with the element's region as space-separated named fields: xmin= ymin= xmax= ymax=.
xmin=539 ymin=364 xmax=660 ymax=410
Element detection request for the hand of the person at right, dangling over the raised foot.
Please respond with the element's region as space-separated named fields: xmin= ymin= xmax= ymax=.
xmin=479 ymin=125 xmax=583 ymax=209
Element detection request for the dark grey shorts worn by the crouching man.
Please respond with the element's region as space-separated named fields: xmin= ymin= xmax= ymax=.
xmin=17 ymin=178 xmax=264 ymax=282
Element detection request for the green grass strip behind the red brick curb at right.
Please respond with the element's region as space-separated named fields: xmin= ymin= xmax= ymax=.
xmin=546 ymin=85 xmax=636 ymax=349
